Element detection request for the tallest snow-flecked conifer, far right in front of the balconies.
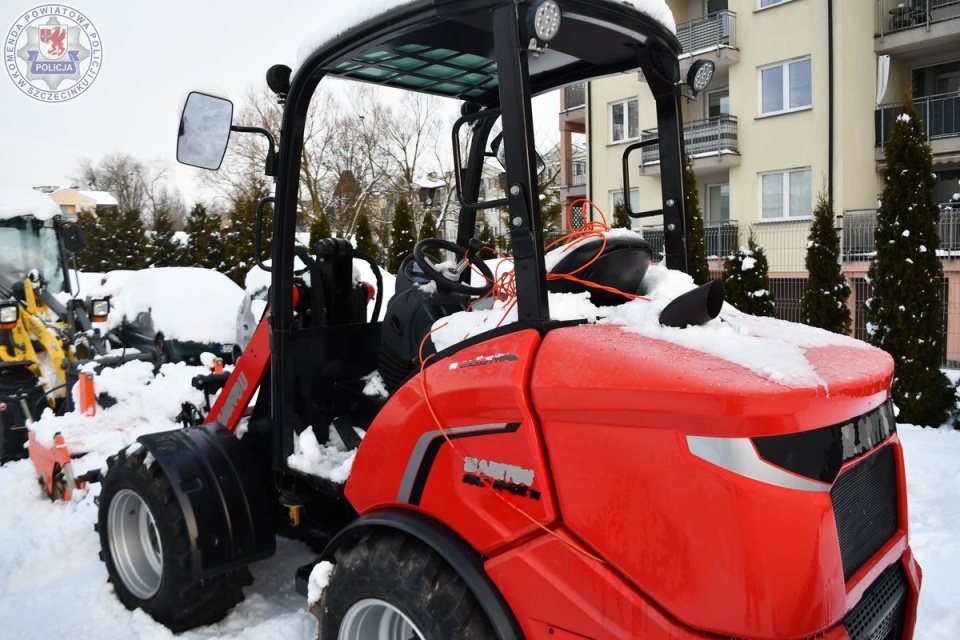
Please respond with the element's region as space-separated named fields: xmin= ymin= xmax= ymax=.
xmin=867 ymin=95 xmax=955 ymax=427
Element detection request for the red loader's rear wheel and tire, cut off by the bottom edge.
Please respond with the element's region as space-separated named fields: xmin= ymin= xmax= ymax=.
xmin=317 ymin=532 xmax=497 ymax=640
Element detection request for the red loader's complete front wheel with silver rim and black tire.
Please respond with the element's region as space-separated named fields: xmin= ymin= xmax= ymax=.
xmin=96 ymin=448 xmax=253 ymax=633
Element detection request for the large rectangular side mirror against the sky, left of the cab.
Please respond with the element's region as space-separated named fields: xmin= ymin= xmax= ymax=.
xmin=177 ymin=91 xmax=233 ymax=171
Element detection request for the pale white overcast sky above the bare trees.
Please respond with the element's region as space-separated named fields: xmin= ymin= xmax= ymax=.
xmin=0 ymin=0 xmax=559 ymax=205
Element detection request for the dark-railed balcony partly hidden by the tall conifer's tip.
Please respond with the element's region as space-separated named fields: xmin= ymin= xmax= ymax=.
xmin=874 ymin=93 xmax=960 ymax=163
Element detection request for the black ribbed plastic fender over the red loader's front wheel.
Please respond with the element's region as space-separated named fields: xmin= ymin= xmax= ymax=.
xmin=137 ymin=423 xmax=276 ymax=579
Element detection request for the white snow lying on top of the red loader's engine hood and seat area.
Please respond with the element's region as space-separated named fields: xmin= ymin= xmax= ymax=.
xmin=431 ymin=230 xmax=873 ymax=388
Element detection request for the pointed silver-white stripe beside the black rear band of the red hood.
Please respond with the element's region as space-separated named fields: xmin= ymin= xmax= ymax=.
xmin=687 ymin=436 xmax=830 ymax=491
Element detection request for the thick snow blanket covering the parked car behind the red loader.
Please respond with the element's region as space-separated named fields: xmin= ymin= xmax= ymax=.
xmin=103 ymin=267 xmax=243 ymax=343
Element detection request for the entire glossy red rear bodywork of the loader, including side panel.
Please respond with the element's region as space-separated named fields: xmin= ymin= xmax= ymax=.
xmin=346 ymin=325 xmax=920 ymax=640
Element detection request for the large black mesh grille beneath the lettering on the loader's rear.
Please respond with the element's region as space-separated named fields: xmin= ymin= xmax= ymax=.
xmin=830 ymin=446 xmax=899 ymax=580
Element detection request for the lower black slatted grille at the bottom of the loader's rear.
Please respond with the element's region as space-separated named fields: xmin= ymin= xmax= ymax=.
xmin=843 ymin=562 xmax=907 ymax=640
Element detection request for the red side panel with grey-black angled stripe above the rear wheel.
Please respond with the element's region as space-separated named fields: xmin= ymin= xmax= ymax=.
xmin=346 ymin=330 xmax=557 ymax=554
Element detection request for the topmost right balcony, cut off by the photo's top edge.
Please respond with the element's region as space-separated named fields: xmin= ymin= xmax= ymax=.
xmin=874 ymin=0 xmax=960 ymax=55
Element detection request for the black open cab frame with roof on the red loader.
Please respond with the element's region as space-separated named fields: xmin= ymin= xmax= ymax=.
xmin=270 ymin=0 xmax=687 ymax=469
